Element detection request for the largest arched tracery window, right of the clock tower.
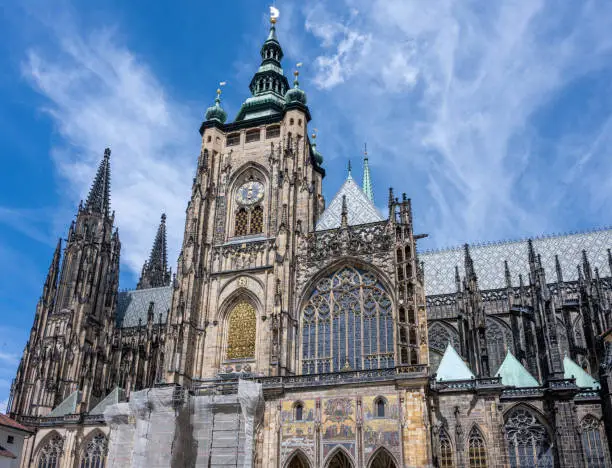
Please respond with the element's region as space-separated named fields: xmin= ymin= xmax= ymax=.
xmin=302 ymin=267 xmax=395 ymax=374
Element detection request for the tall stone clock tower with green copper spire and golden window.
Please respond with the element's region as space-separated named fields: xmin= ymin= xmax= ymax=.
xmin=165 ymin=18 xmax=325 ymax=385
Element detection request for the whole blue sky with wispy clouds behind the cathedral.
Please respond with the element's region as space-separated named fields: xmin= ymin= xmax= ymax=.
xmin=0 ymin=0 xmax=612 ymax=410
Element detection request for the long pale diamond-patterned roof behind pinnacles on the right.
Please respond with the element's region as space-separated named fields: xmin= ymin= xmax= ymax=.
xmin=419 ymin=228 xmax=612 ymax=296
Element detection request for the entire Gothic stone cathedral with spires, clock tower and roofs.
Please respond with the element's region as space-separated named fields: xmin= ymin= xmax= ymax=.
xmin=9 ymin=14 xmax=612 ymax=468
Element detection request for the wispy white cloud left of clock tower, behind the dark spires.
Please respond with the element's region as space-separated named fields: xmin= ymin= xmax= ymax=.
xmin=22 ymin=26 xmax=199 ymax=273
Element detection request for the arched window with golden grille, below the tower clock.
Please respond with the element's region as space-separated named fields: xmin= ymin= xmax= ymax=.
xmin=227 ymin=301 xmax=257 ymax=359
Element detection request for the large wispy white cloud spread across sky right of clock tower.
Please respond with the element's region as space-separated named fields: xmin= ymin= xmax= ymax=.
xmin=294 ymin=0 xmax=612 ymax=245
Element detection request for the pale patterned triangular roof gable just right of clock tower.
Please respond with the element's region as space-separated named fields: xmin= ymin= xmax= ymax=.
xmin=315 ymin=177 xmax=384 ymax=231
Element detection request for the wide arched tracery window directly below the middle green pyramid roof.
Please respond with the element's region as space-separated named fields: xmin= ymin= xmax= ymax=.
xmin=505 ymin=408 xmax=553 ymax=468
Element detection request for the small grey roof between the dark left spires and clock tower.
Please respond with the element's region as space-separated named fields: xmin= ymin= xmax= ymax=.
xmin=117 ymin=286 xmax=172 ymax=328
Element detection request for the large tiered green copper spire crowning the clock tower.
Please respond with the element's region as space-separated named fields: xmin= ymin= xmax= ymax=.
xmin=236 ymin=18 xmax=289 ymax=122
